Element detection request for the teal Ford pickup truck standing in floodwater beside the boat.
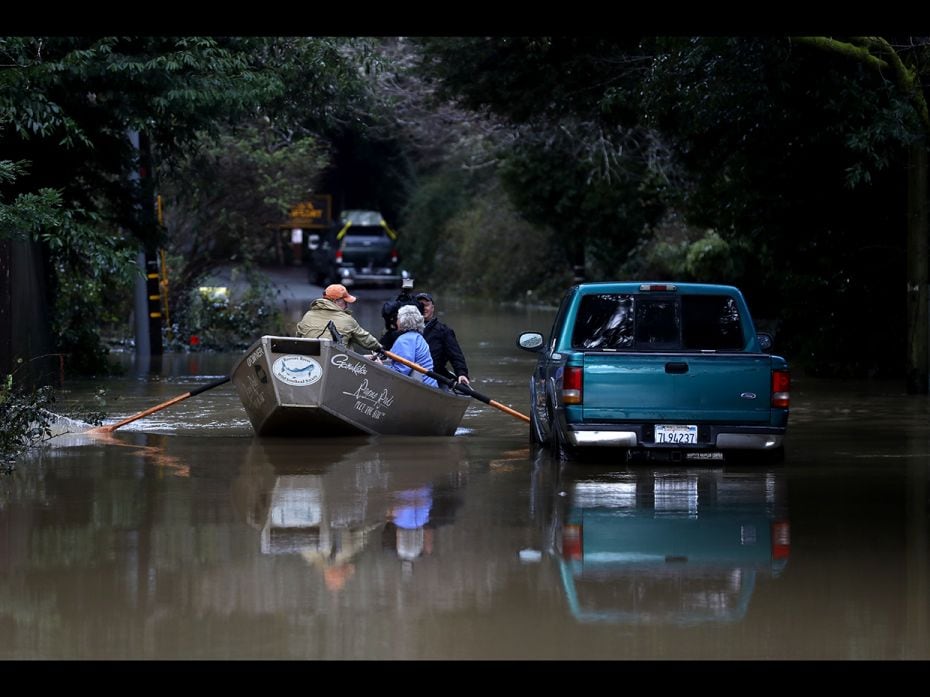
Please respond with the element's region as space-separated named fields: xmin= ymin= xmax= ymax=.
xmin=517 ymin=282 xmax=790 ymax=462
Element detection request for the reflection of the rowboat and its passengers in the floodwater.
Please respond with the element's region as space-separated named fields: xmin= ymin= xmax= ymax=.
xmin=234 ymin=437 xmax=467 ymax=591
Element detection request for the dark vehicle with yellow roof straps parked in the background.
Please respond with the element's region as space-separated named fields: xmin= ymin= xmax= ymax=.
xmin=336 ymin=210 xmax=401 ymax=286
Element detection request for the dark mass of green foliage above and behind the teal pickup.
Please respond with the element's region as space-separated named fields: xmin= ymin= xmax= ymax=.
xmin=419 ymin=36 xmax=930 ymax=376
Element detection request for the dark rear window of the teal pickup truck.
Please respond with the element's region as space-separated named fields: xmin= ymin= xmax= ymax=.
xmin=572 ymin=293 xmax=744 ymax=351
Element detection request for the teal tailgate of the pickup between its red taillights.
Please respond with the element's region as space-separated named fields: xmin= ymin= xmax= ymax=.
xmin=582 ymin=353 xmax=772 ymax=424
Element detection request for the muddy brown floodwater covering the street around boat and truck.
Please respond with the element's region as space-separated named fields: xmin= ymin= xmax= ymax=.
xmin=0 ymin=293 xmax=930 ymax=660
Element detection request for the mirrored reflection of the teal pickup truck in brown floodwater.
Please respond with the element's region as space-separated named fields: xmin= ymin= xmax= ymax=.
xmin=553 ymin=468 xmax=790 ymax=625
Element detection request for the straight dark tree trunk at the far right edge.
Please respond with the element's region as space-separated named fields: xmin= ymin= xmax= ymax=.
xmin=906 ymin=141 xmax=930 ymax=394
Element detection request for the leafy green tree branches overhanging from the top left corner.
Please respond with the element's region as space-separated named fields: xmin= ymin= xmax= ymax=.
xmin=0 ymin=37 xmax=374 ymax=376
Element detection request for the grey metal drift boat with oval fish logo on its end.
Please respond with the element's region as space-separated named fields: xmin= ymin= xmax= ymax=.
xmin=231 ymin=336 xmax=470 ymax=437
